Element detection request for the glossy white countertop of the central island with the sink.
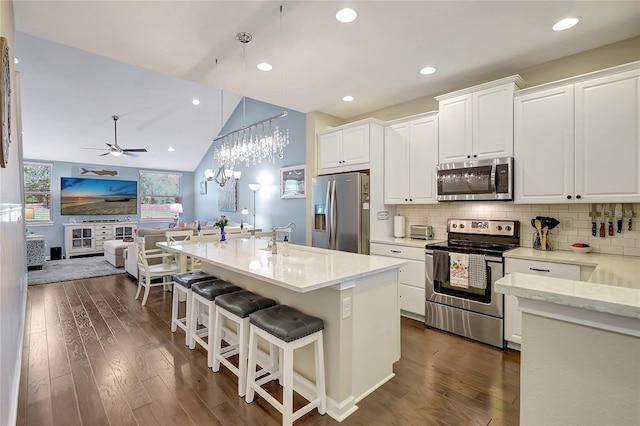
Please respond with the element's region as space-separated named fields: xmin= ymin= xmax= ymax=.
xmin=157 ymin=238 xmax=407 ymax=293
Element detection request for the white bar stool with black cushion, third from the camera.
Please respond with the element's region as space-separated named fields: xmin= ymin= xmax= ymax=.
xmin=189 ymin=280 xmax=242 ymax=368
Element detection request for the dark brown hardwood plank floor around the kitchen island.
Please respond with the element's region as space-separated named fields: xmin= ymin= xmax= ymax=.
xmin=17 ymin=275 xmax=520 ymax=426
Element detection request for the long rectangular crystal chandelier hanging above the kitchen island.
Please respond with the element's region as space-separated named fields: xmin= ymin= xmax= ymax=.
xmin=209 ymin=26 xmax=289 ymax=186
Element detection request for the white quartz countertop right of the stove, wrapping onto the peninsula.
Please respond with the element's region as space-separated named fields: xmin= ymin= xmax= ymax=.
xmin=495 ymin=247 xmax=640 ymax=318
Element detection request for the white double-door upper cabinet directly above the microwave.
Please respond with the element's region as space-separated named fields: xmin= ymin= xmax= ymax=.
xmin=435 ymin=75 xmax=524 ymax=163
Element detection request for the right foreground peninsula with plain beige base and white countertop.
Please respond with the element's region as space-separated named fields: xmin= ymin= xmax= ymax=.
xmin=495 ymin=248 xmax=640 ymax=426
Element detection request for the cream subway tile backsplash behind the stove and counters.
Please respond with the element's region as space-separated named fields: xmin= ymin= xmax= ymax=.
xmin=396 ymin=201 xmax=640 ymax=256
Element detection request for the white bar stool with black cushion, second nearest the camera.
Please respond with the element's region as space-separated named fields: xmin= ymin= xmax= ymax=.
xmin=212 ymin=290 xmax=276 ymax=396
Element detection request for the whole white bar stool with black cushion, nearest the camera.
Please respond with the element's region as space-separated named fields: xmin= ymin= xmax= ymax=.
xmin=246 ymin=305 xmax=327 ymax=426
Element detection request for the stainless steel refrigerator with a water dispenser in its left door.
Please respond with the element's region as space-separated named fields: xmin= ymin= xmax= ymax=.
xmin=311 ymin=172 xmax=370 ymax=254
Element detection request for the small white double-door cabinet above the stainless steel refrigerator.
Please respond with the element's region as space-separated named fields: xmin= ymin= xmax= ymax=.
xmin=318 ymin=122 xmax=379 ymax=175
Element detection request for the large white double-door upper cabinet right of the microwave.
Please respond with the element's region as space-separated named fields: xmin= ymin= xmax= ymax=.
xmin=514 ymin=62 xmax=640 ymax=203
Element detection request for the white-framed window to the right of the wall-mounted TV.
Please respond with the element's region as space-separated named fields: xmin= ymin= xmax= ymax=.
xmin=140 ymin=171 xmax=182 ymax=219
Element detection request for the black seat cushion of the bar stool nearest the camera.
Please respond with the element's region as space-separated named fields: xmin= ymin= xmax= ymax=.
xmin=249 ymin=305 xmax=324 ymax=343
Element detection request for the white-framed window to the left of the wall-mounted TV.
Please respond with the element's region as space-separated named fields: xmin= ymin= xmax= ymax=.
xmin=23 ymin=162 xmax=53 ymax=223
